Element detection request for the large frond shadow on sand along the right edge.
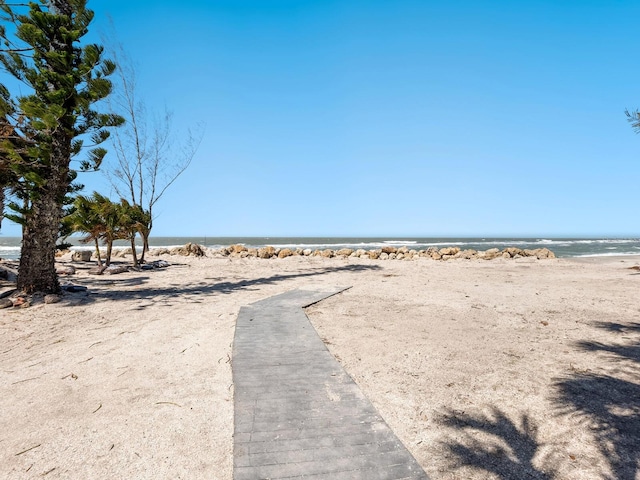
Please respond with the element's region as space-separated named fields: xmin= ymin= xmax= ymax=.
xmin=555 ymin=322 xmax=640 ymax=480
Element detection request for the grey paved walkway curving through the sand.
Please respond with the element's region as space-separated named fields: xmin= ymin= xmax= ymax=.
xmin=232 ymin=287 xmax=427 ymax=480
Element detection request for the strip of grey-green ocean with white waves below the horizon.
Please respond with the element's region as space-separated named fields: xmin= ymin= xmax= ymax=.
xmin=0 ymin=235 xmax=640 ymax=260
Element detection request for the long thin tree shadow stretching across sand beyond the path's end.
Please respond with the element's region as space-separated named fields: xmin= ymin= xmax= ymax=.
xmin=58 ymin=265 xmax=382 ymax=303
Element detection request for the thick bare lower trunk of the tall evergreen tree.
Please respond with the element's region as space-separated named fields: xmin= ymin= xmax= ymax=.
xmin=17 ymin=192 xmax=62 ymax=293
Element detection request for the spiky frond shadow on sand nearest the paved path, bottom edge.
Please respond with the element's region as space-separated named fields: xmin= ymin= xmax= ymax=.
xmin=440 ymin=407 xmax=552 ymax=480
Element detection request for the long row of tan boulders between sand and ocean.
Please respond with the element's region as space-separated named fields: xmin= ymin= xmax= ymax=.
xmin=148 ymin=243 xmax=556 ymax=260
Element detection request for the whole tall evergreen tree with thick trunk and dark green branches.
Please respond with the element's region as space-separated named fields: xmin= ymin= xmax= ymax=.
xmin=0 ymin=0 xmax=123 ymax=293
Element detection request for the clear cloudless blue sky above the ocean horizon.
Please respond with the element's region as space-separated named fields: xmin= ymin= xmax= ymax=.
xmin=2 ymin=0 xmax=640 ymax=236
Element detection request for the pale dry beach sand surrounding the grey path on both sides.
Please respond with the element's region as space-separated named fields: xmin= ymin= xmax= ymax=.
xmin=0 ymin=253 xmax=640 ymax=480
